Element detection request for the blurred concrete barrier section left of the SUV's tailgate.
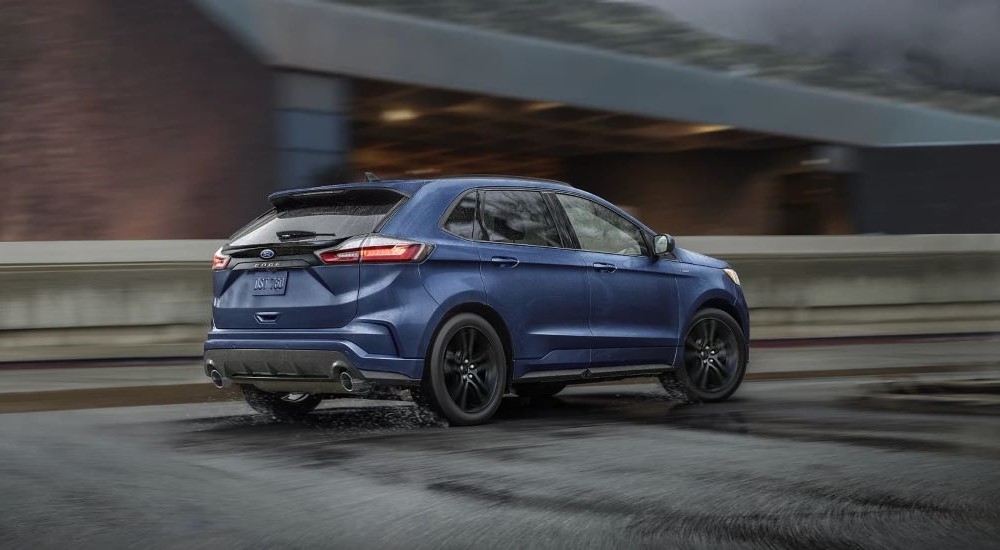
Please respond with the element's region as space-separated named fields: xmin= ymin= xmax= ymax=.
xmin=0 ymin=240 xmax=222 ymax=362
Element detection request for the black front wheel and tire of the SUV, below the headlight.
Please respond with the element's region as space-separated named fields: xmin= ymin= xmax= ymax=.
xmin=660 ymin=309 xmax=748 ymax=403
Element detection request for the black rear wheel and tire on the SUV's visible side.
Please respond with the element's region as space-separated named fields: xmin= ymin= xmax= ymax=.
xmin=416 ymin=313 xmax=507 ymax=426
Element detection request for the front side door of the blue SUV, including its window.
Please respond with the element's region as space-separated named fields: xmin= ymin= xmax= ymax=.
xmin=555 ymin=193 xmax=679 ymax=366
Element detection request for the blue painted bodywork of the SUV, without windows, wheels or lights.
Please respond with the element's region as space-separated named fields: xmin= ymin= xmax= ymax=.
xmin=205 ymin=177 xmax=749 ymax=379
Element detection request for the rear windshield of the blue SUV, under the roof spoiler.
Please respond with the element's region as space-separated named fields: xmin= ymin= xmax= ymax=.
xmin=229 ymin=189 xmax=405 ymax=246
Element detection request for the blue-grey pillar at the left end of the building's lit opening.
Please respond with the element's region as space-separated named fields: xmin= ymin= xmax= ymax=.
xmin=276 ymin=71 xmax=351 ymax=189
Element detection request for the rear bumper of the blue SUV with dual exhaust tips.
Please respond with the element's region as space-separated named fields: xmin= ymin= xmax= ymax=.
xmin=204 ymin=339 xmax=423 ymax=393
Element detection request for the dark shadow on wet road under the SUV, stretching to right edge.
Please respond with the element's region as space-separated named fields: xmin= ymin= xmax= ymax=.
xmin=164 ymin=386 xmax=997 ymax=465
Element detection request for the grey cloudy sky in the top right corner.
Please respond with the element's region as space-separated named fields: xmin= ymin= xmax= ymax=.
xmin=626 ymin=0 xmax=1000 ymax=93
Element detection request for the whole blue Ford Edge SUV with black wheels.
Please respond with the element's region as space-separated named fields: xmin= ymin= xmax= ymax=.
xmin=204 ymin=176 xmax=749 ymax=425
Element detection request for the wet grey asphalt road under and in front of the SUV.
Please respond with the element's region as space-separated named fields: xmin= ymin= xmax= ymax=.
xmin=0 ymin=380 xmax=1000 ymax=549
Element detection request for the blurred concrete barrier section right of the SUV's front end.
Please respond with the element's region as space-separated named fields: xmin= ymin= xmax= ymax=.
xmin=678 ymin=235 xmax=1000 ymax=339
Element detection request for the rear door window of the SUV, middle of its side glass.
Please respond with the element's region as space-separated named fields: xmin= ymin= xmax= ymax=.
xmin=479 ymin=190 xmax=562 ymax=247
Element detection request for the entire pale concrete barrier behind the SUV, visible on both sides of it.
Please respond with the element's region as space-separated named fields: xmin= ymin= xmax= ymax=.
xmin=0 ymin=235 xmax=1000 ymax=362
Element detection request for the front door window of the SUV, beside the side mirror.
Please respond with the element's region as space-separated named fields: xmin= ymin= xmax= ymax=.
xmin=556 ymin=193 xmax=647 ymax=256
